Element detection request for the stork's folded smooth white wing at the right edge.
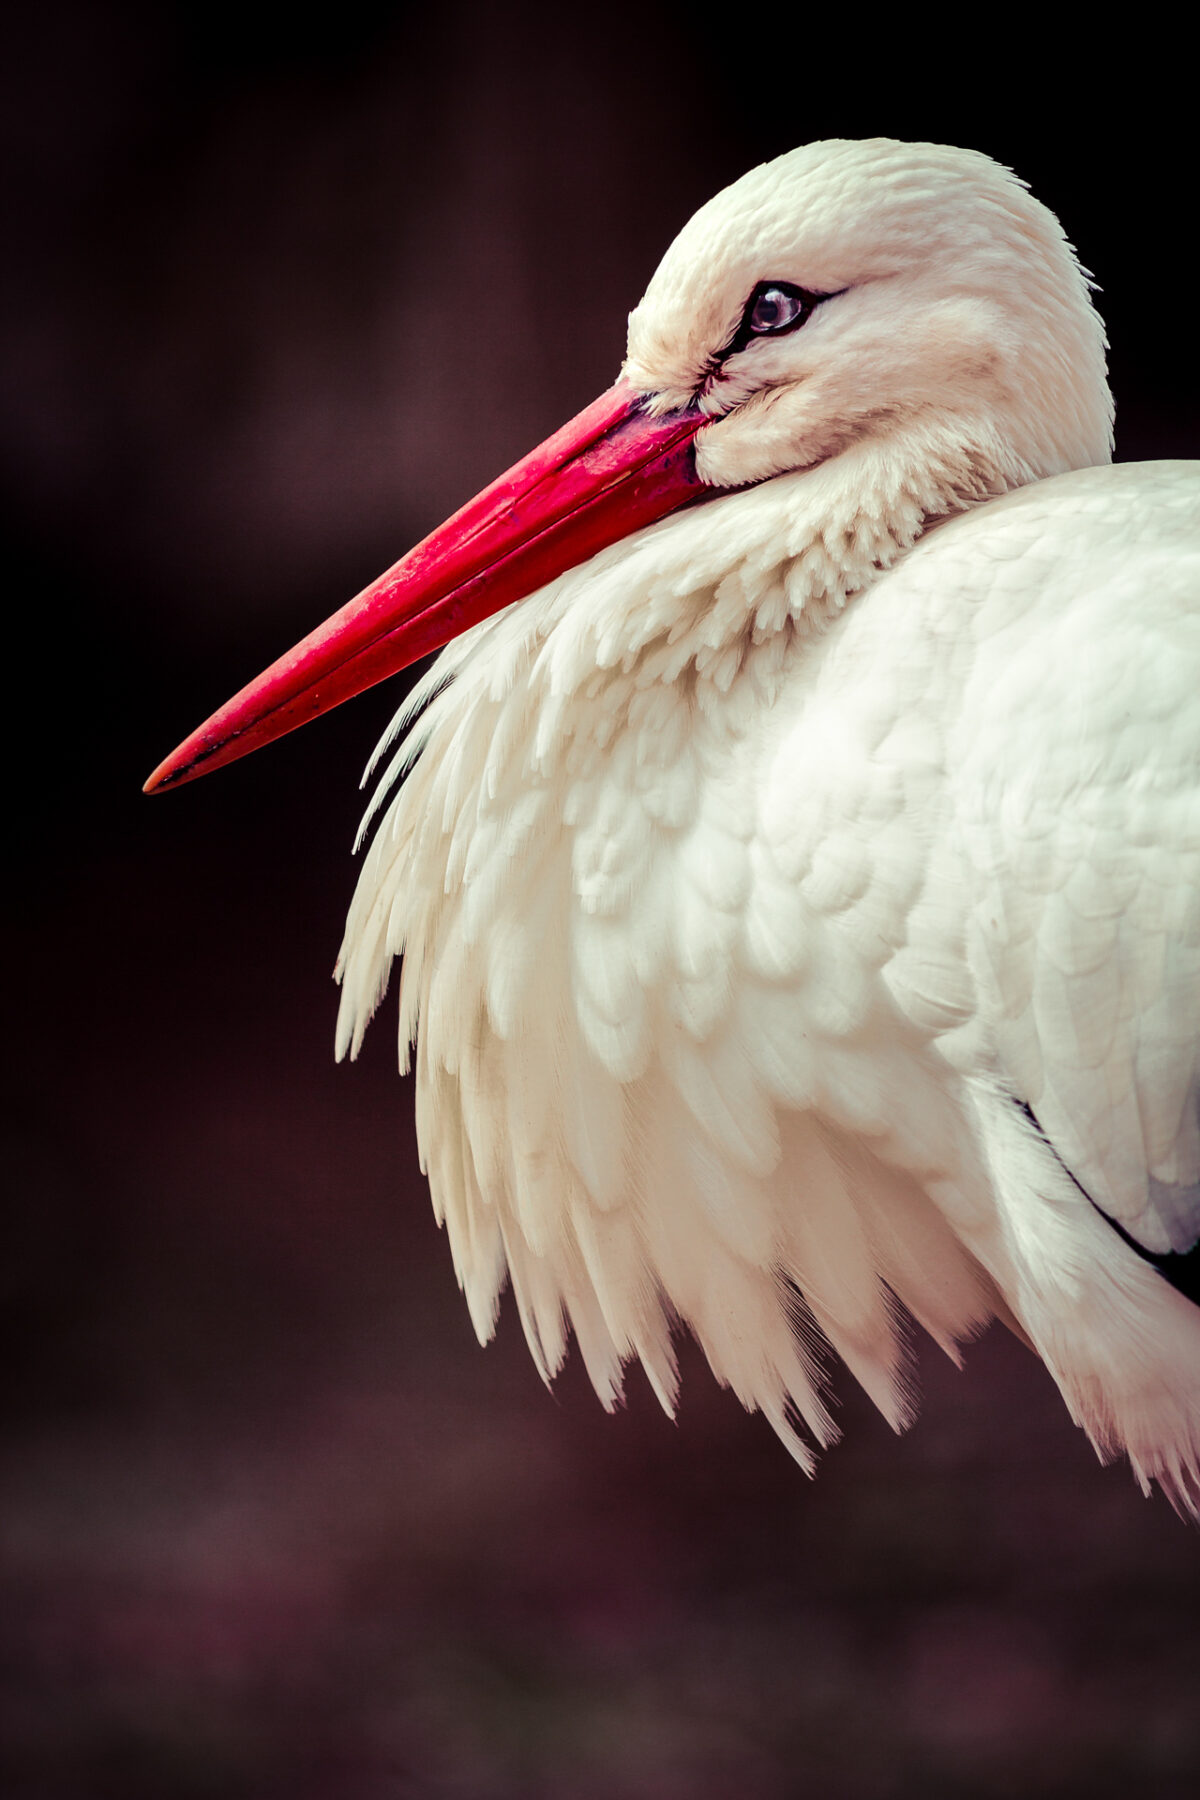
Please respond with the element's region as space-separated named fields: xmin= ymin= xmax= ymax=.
xmin=950 ymin=471 xmax=1200 ymax=1253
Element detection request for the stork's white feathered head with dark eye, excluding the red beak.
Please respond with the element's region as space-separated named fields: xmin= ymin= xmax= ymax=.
xmin=624 ymin=139 xmax=1112 ymax=491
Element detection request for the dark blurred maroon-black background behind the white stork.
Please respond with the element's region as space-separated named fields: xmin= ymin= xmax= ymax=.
xmin=0 ymin=0 xmax=1200 ymax=1800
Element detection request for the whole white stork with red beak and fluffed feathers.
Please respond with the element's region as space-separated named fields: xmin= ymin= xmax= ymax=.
xmin=148 ymin=140 xmax=1200 ymax=1514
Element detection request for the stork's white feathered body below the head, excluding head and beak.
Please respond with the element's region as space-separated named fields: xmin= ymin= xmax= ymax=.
xmin=342 ymin=453 xmax=1200 ymax=1504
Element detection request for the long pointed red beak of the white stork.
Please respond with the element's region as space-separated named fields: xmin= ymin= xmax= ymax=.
xmin=146 ymin=382 xmax=712 ymax=794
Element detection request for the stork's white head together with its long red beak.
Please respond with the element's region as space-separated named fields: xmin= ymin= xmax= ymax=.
xmin=146 ymin=139 xmax=1112 ymax=790
